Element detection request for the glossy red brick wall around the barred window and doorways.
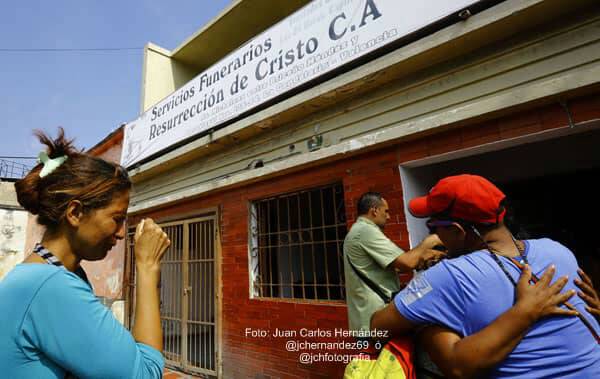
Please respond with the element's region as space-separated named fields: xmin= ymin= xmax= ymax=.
xmin=133 ymin=96 xmax=600 ymax=379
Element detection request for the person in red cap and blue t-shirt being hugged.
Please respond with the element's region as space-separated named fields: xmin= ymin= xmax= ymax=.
xmin=371 ymin=175 xmax=600 ymax=378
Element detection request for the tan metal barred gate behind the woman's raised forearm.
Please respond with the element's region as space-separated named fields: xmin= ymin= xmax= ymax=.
xmin=128 ymin=216 xmax=218 ymax=377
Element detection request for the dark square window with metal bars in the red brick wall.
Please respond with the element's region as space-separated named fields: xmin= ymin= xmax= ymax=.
xmin=249 ymin=183 xmax=347 ymax=300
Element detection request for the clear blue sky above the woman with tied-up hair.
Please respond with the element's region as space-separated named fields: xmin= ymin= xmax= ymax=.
xmin=0 ymin=0 xmax=232 ymax=156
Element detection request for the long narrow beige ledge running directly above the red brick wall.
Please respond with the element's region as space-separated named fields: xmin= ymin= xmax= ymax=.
xmin=129 ymin=62 xmax=600 ymax=214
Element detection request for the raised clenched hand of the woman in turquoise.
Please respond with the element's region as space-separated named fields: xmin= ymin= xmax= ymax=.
xmin=134 ymin=218 xmax=171 ymax=272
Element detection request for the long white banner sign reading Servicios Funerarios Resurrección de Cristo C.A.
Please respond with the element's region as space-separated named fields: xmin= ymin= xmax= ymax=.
xmin=121 ymin=0 xmax=478 ymax=167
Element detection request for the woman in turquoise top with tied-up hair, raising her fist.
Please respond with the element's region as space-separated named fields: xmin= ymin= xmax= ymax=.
xmin=0 ymin=129 xmax=170 ymax=379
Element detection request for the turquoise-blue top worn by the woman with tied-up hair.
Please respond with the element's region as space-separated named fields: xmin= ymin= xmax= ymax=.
xmin=0 ymin=263 xmax=164 ymax=379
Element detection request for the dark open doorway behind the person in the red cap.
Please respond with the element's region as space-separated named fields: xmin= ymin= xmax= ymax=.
xmin=400 ymin=125 xmax=600 ymax=288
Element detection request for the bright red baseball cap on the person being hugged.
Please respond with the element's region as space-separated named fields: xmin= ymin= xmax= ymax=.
xmin=408 ymin=174 xmax=506 ymax=224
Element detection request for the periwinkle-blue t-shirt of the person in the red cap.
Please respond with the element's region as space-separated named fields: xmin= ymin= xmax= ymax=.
xmin=394 ymin=239 xmax=600 ymax=379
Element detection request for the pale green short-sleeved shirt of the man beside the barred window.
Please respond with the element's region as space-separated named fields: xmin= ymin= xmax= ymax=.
xmin=344 ymin=217 xmax=404 ymax=330
